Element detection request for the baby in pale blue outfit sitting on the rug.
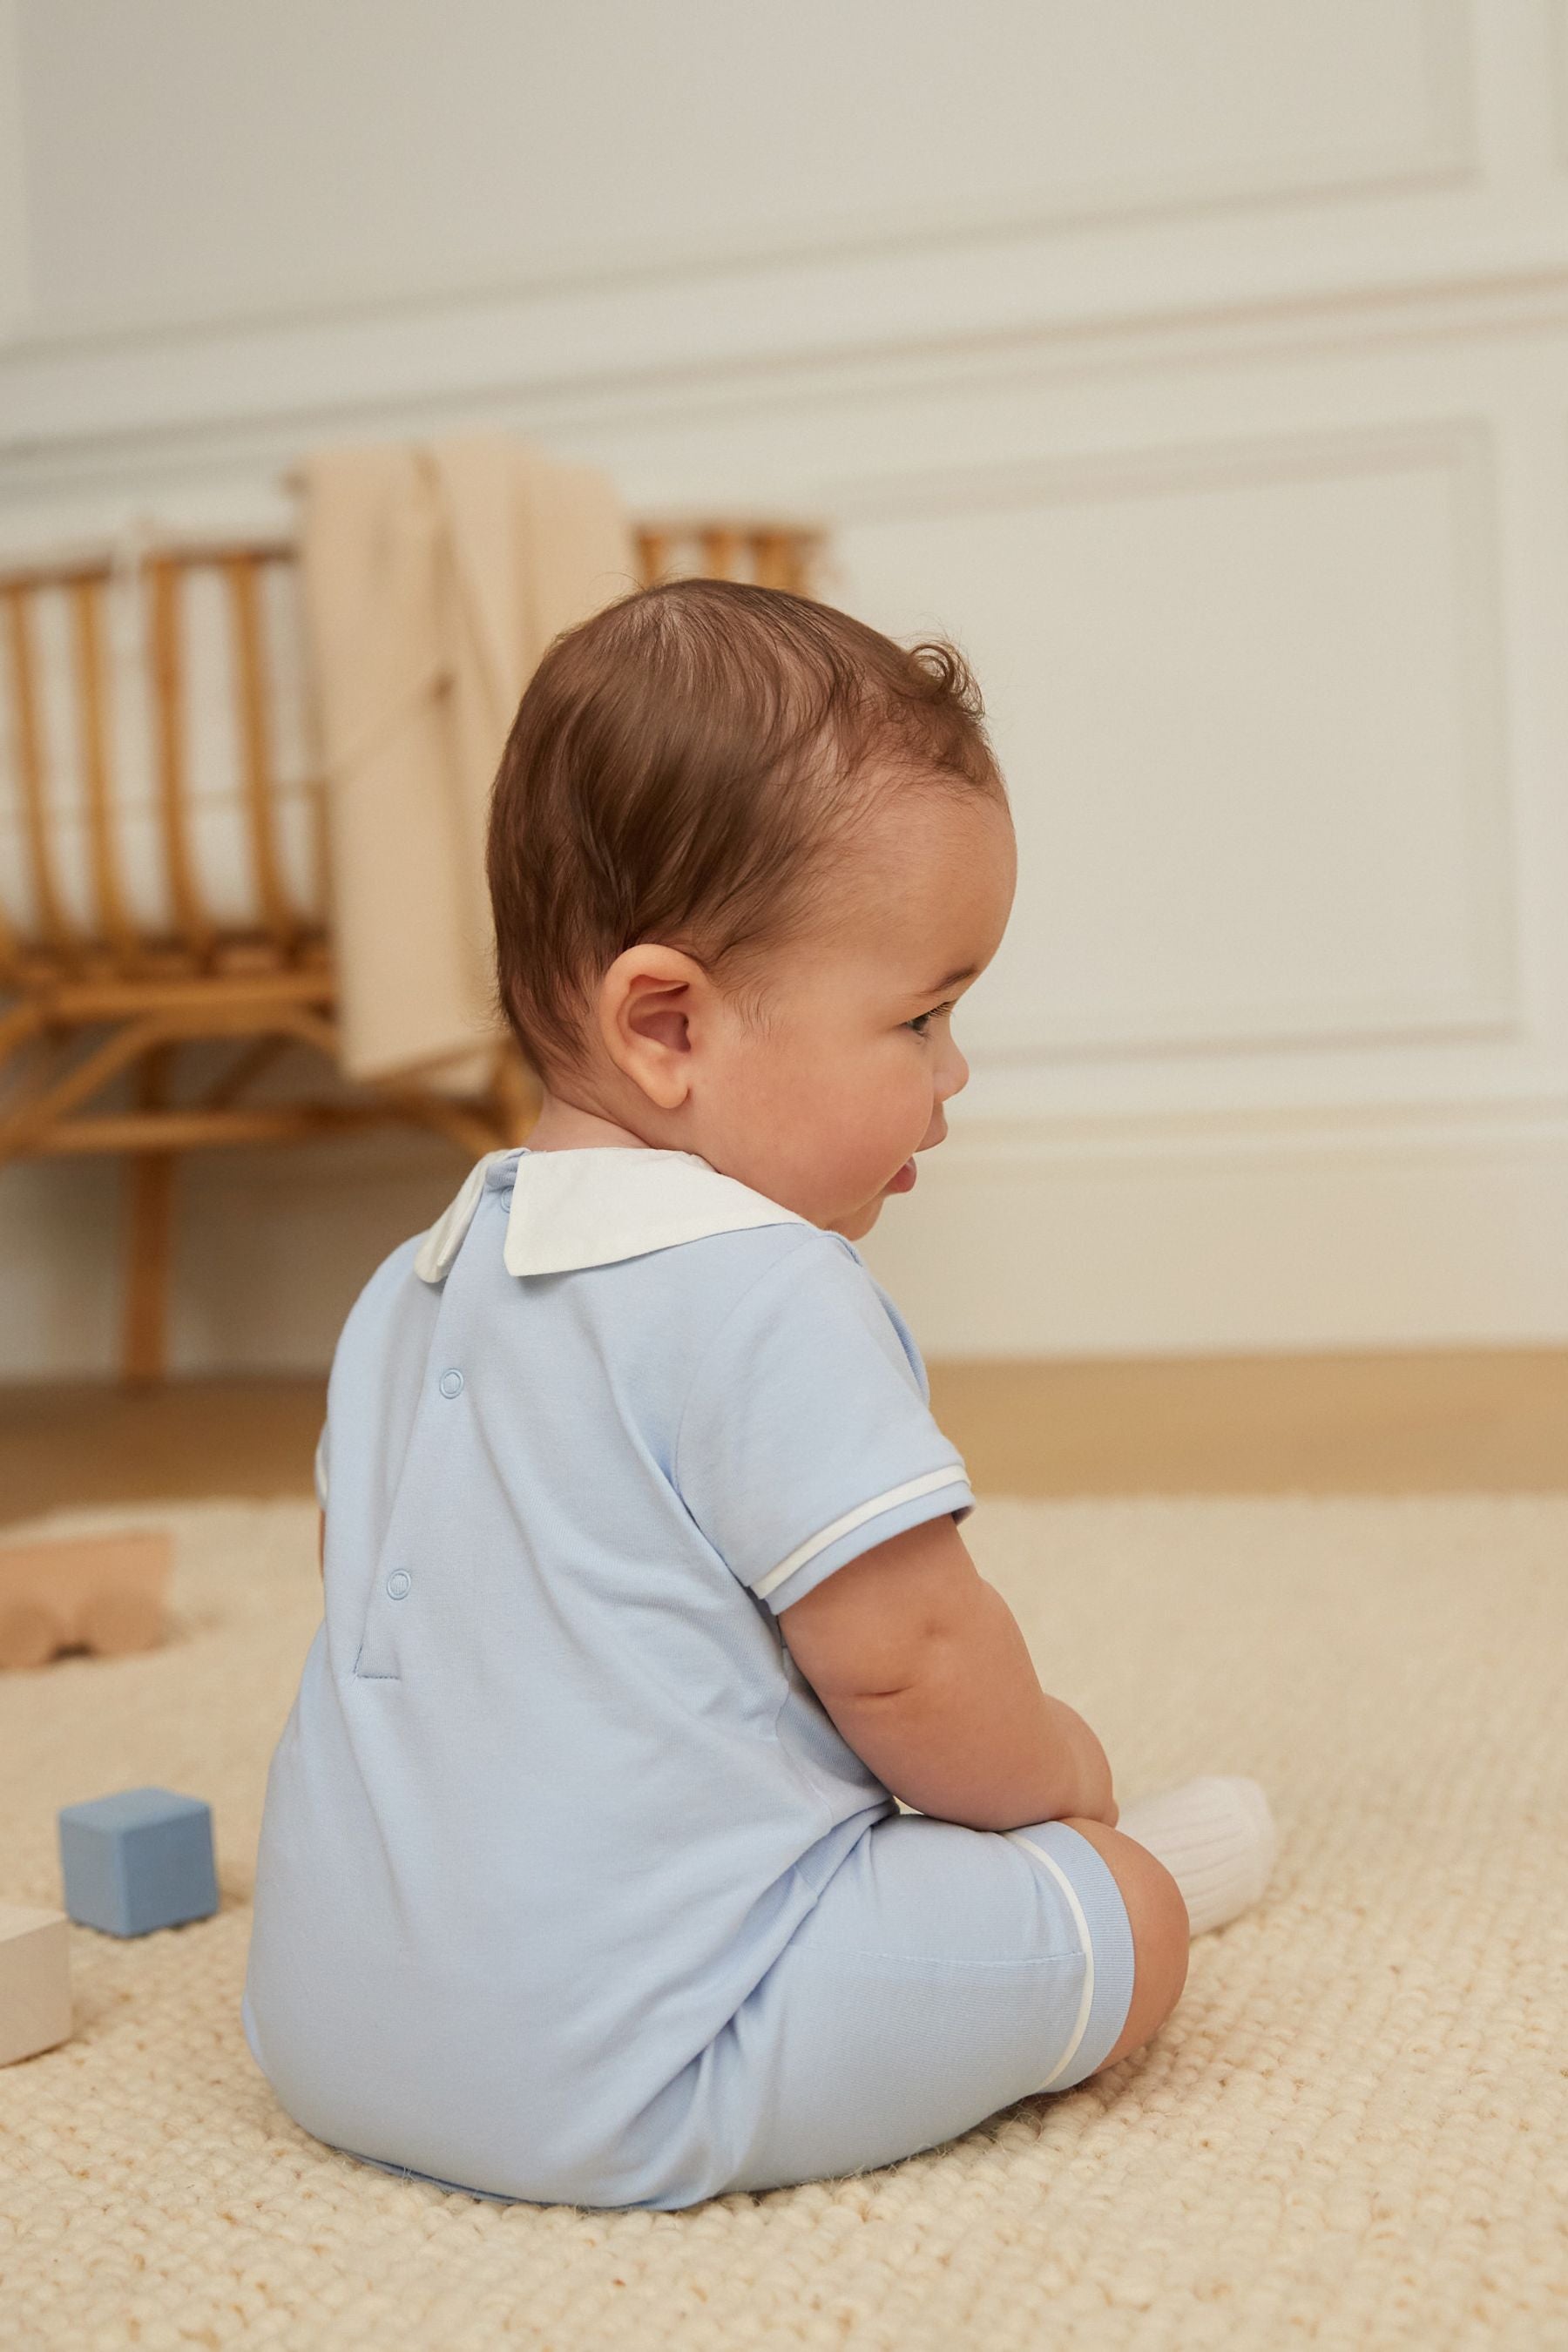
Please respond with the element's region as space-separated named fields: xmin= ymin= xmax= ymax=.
xmin=245 ymin=581 xmax=1274 ymax=2208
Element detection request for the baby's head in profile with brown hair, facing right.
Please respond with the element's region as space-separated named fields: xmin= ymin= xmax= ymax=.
xmin=489 ymin=581 xmax=1016 ymax=1240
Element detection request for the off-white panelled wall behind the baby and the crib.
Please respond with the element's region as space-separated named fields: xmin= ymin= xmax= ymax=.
xmin=0 ymin=0 xmax=1568 ymax=1376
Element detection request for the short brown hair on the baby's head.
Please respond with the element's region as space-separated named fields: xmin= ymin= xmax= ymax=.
xmin=487 ymin=581 xmax=1006 ymax=1071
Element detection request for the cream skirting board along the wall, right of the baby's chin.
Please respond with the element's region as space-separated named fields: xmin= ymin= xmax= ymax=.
xmin=862 ymin=1132 xmax=1568 ymax=1357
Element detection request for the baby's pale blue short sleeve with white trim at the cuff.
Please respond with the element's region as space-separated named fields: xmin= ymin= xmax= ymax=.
xmin=675 ymin=1237 xmax=973 ymax=1613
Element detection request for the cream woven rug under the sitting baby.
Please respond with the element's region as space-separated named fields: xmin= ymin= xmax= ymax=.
xmin=0 ymin=1496 xmax=1568 ymax=2352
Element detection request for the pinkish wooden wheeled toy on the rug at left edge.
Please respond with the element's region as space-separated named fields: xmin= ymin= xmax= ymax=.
xmin=0 ymin=1529 xmax=174 ymax=1666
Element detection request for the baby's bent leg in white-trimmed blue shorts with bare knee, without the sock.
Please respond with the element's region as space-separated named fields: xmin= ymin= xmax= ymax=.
xmin=658 ymin=1814 xmax=1187 ymax=2204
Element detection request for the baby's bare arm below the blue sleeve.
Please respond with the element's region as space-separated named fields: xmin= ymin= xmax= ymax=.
xmin=778 ymin=1517 xmax=1117 ymax=1830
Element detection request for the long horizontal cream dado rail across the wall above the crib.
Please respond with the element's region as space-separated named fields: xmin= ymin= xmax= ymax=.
xmin=0 ymin=257 xmax=1568 ymax=501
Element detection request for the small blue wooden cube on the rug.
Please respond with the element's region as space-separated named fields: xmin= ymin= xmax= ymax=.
xmin=58 ymin=1788 xmax=219 ymax=1936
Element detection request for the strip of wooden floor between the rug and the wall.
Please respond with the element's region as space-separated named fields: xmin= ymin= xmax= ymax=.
xmin=0 ymin=1348 xmax=1568 ymax=1524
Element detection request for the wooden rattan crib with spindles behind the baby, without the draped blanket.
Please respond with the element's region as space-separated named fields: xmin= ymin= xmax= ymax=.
xmin=0 ymin=520 xmax=821 ymax=1381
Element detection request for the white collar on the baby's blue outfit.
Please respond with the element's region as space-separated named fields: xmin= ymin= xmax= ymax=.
xmin=414 ymin=1146 xmax=807 ymax=1282
